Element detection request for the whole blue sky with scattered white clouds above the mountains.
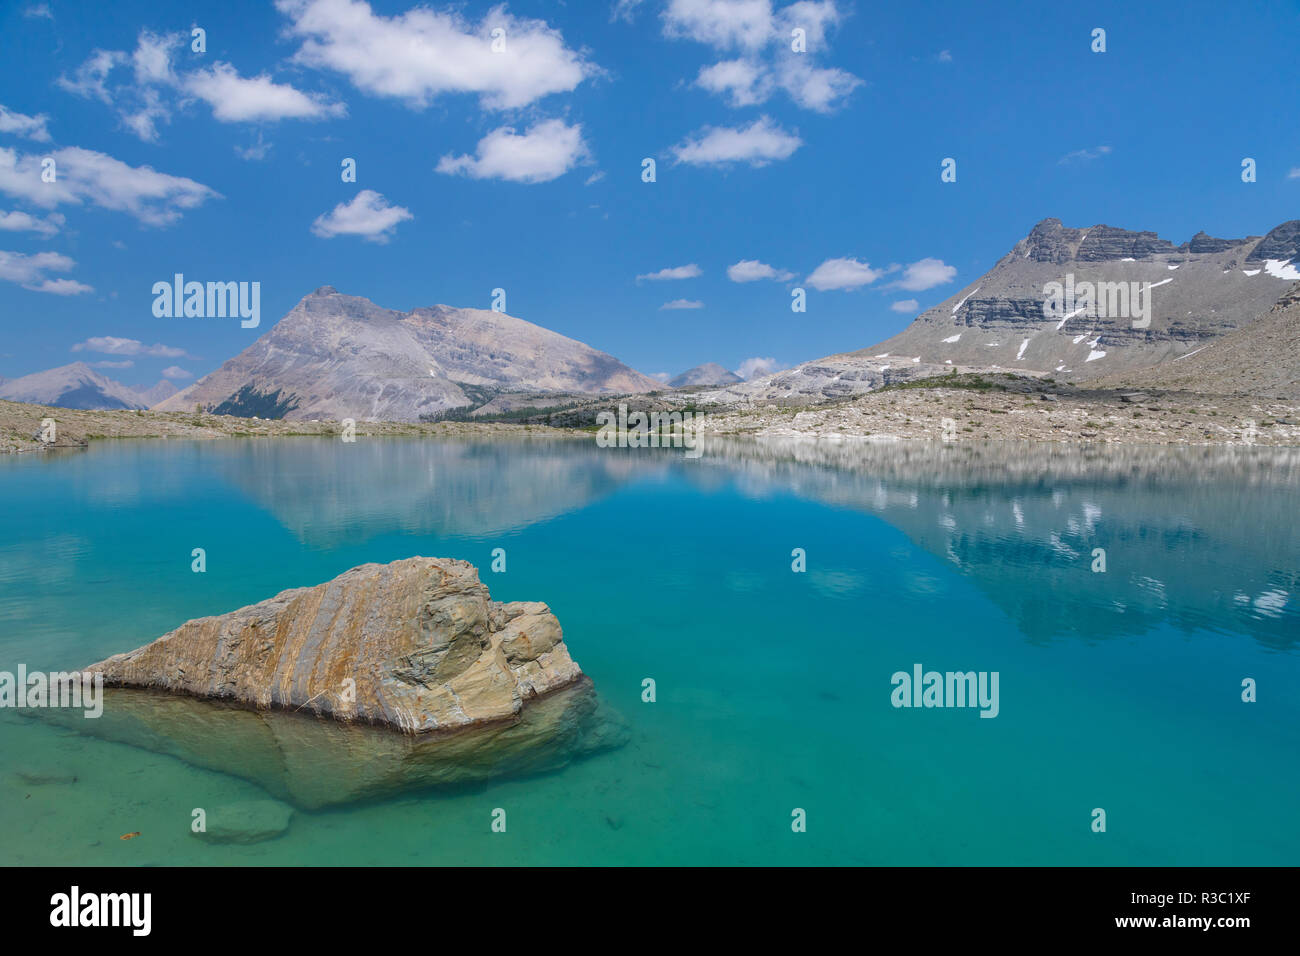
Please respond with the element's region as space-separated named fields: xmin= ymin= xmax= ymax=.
xmin=0 ymin=0 xmax=1300 ymax=386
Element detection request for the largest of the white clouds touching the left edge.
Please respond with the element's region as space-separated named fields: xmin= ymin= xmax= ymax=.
xmin=0 ymin=146 xmax=221 ymax=226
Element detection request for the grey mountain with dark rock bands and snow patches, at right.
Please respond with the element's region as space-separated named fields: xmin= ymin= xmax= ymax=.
xmin=701 ymin=219 xmax=1300 ymax=405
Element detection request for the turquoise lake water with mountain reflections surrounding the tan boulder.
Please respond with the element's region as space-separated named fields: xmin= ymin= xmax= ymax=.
xmin=0 ymin=438 xmax=1300 ymax=865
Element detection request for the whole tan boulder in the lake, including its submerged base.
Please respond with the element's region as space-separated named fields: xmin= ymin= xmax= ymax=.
xmin=62 ymin=558 xmax=625 ymax=808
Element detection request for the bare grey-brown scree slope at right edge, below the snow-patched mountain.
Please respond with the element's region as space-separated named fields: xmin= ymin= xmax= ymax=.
xmin=1097 ymin=282 xmax=1300 ymax=399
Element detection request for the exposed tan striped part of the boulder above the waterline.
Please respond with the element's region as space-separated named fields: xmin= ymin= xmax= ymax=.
xmin=85 ymin=558 xmax=582 ymax=734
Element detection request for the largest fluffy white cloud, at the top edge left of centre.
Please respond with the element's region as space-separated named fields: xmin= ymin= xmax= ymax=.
xmin=276 ymin=0 xmax=597 ymax=109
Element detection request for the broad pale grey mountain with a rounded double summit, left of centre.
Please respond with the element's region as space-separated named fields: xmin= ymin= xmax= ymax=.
xmin=157 ymin=286 xmax=663 ymax=421
